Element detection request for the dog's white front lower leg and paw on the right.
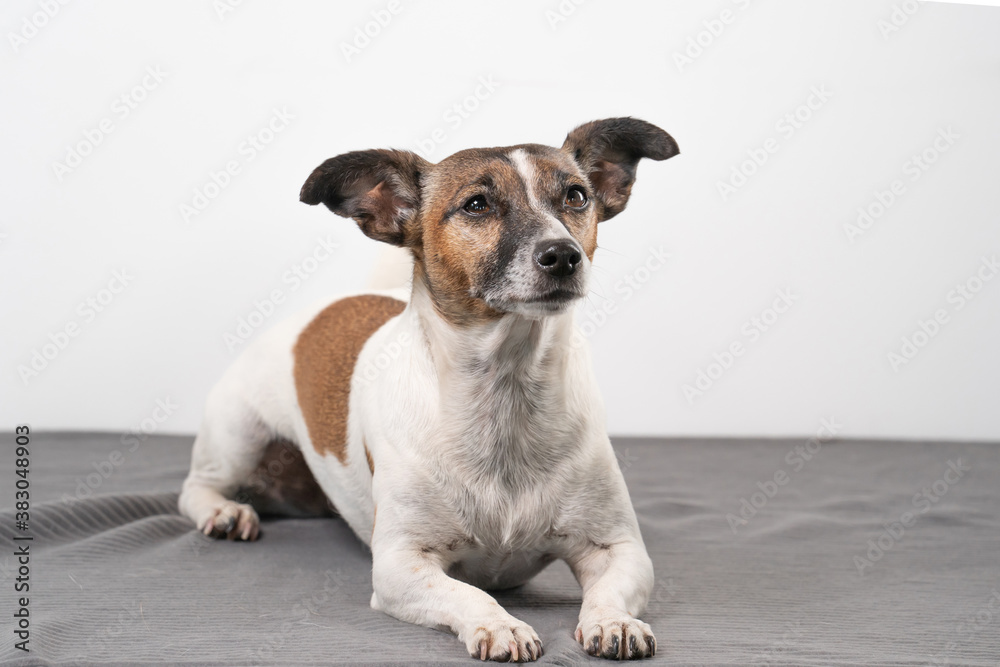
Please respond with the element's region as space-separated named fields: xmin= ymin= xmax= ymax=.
xmin=567 ymin=540 xmax=656 ymax=660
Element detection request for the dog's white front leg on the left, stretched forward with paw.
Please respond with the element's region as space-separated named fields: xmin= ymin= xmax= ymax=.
xmin=372 ymin=528 xmax=542 ymax=662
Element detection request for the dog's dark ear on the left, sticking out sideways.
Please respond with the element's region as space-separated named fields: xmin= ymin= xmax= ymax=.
xmin=299 ymin=150 xmax=430 ymax=246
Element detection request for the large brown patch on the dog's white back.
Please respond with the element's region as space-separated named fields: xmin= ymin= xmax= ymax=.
xmin=293 ymin=294 xmax=406 ymax=465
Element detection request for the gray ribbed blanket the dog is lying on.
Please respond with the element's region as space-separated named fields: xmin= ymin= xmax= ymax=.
xmin=0 ymin=434 xmax=1000 ymax=667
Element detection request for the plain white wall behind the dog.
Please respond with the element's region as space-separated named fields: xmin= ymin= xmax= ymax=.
xmin=0 ymin=0 xmax=1000 ymax=439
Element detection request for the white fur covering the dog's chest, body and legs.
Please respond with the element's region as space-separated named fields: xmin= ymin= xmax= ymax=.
xmin=180 ymin=151 xmax=653 ymax=660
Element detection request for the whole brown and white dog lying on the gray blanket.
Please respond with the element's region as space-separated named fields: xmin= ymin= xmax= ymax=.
xmin=180 ymin=118 xmax=678 ymax=661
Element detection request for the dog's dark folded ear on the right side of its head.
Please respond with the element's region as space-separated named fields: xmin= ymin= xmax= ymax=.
xmin=562 ymin=118 xmax=680 ymax=222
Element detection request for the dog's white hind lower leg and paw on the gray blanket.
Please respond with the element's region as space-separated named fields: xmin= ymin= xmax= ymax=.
xmin=178 ymin=401 xmax=271 ymax=540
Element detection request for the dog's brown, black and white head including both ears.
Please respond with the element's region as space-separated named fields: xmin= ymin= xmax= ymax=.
xmin=300 ymin=118 xmax=679 ymax=323
